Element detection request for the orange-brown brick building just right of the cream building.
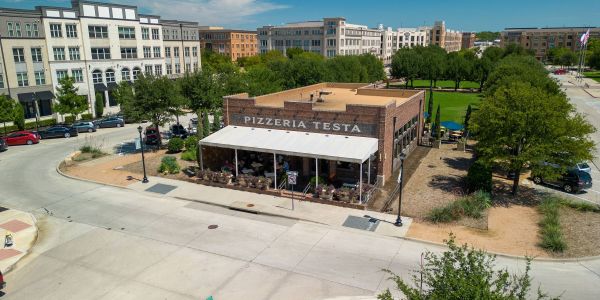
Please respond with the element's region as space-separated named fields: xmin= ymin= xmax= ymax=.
xmin=200 ymin=27 xmax=258 ymax=61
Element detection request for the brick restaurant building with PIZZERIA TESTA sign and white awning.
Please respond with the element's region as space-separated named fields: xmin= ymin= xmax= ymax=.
xmin=199 ymin=83 xmax=425 ymax=202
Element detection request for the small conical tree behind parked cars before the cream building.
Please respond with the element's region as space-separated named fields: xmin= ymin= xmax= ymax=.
xmin=54 ymin=76 xmax=88 ymax=120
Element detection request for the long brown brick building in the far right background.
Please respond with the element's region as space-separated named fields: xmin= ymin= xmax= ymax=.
xmin=500 ymin=27 xmax=600 ymax=60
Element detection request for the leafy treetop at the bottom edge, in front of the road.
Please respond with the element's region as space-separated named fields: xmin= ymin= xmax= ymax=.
xmin=377 ymin=234 xmax=558 ymax=300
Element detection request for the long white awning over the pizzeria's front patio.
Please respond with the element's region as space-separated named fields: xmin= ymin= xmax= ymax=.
xmin=199 ymin=125 xmax=378 ymax=163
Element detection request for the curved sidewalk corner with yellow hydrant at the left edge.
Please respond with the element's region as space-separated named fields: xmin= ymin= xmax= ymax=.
xmin=0 ymin=209 xmax=37 ymax=274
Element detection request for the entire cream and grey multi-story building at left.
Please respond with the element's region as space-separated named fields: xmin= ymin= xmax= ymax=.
xmin=0 ymin=0 xmax=200 ymax=122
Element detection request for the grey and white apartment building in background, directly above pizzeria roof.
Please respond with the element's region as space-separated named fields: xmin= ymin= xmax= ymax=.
xmin=258 ymin=18 xmax=383 ymax=58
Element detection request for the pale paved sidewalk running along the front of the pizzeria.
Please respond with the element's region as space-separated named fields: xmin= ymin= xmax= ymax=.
xmin=128 ymin=177 xmax=412 ymax=237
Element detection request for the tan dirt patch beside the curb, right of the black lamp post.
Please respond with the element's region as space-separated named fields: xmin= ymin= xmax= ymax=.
xmin=407 ymin=205 xmax=550 ymax=257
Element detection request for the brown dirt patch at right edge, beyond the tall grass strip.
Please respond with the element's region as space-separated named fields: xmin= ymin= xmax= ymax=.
xmin=553 ymin=207 xmax=600 ymax=257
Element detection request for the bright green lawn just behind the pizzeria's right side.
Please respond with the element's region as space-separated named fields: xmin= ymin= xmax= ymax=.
xmin=425 ymin=91 xmax=482 ymax=124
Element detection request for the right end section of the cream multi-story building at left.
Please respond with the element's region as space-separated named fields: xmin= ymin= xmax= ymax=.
xmin=161 ymin=20 xmax=201 ymax=78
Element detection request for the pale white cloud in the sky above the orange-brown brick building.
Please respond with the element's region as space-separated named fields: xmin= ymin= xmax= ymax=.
xmin=120 ymin=0 xmax=288 ymax=27
